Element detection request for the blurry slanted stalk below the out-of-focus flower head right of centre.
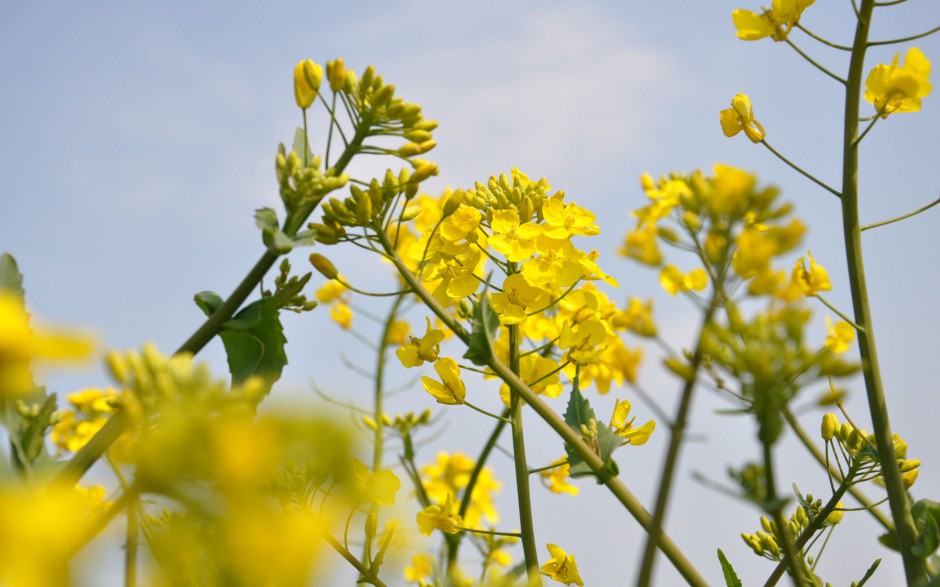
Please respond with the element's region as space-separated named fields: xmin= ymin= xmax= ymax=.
xmin=636 ymin=271 xmax=725 ymax=587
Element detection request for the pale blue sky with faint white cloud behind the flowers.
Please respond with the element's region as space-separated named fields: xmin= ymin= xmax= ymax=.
xmin=0 ymin=0 xmax=940 ymax=586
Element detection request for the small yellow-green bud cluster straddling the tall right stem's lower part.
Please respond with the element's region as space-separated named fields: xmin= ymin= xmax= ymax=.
xmin=820 ymin=413 xmax=920 ymax=489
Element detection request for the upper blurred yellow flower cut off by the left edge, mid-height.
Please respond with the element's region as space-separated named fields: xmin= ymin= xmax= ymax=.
xmin=0 ymin=291 xmax=92 ymax=398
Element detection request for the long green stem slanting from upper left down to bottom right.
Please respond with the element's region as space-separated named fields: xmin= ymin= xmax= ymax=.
xmin=378 ymin=233 xmax=708 ymax=587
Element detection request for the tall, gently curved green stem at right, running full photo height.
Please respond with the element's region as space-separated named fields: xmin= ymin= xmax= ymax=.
xmin=842 ymin=0 xmax=927 ymax=585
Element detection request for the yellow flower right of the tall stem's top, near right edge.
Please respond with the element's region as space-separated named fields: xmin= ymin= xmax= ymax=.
xmin=865 ymin=47 xmax=933 ymax=118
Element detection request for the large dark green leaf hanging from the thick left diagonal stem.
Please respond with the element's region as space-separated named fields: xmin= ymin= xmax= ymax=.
xmin=220 ymin=298 xmax=287 ymax=389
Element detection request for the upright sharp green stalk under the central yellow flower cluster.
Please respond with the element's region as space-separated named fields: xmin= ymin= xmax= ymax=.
xmin=509 ymin=324 xmax=542 ymax=587
